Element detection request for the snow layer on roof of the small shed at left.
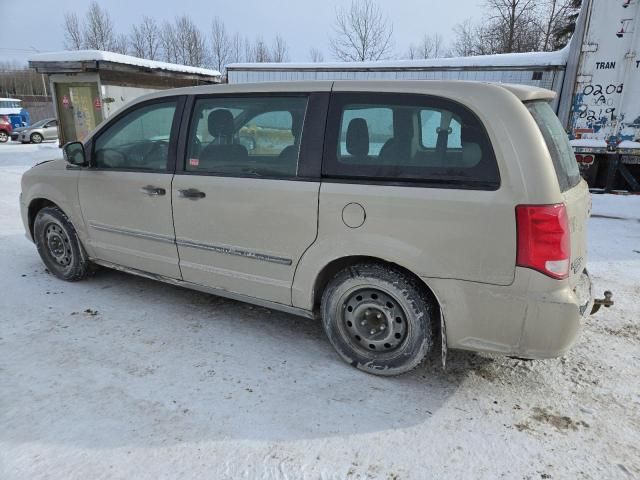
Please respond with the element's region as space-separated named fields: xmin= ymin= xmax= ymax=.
xmin=29 ymin=50 xmax=220 ymax=77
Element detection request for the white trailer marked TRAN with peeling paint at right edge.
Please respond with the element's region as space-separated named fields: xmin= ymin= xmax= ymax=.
xmin=560 ymin=0 xmax=640 ymax=191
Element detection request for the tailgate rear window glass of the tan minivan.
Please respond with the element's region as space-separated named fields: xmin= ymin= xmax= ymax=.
xmin=527 ymin=102 xmax=580 ymax=192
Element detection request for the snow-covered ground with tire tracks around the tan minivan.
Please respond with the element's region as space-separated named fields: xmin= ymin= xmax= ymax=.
xmin=0 ymin=144 xmax=640 ymax=480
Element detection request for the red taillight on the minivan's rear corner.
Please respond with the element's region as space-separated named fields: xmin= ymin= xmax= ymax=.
xmin=516 ymin=203 xmax=571 ymax=279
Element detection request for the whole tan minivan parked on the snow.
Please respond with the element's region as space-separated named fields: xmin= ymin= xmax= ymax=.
xmin=21 ymin=81 xmax=592 ymax=375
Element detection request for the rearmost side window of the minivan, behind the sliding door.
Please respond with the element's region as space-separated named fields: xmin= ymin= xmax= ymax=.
xmin=323 ymin=93 xmax=500 ymax=189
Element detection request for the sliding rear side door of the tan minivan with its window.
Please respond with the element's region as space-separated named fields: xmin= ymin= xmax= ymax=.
xmin=172 ymin=95 xmax=324 ymax=305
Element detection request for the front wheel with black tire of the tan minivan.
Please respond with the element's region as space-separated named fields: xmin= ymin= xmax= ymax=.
xmin=33 ymin=207 xmax=93 ymax=282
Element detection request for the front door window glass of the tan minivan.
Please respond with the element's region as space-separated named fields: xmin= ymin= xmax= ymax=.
xmin=94 ymin=100 xmax=177 ymax=171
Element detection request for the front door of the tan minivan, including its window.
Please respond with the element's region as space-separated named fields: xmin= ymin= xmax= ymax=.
xmin=78 ymin=98 xmax=182 ymax=278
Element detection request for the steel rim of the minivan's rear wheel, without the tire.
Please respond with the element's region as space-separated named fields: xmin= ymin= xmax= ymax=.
xmin=339 ymin=286 xmax=409 ymax=355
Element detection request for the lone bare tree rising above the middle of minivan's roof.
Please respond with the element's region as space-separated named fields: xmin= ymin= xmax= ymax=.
xmin=330 ymin=0 xmax=393 ymax=62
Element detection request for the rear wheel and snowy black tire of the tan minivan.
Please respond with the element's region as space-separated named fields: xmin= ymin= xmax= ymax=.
xmin=321 ymin=263 xmax=436 ymax=376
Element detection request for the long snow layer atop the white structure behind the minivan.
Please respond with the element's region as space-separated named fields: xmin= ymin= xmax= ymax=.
xmin=227 ymin=45 xmax=569 ymax=70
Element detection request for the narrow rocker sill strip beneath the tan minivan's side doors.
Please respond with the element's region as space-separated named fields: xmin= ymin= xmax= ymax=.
xmin=90 ymin=258 xmax=320 ymax=319
